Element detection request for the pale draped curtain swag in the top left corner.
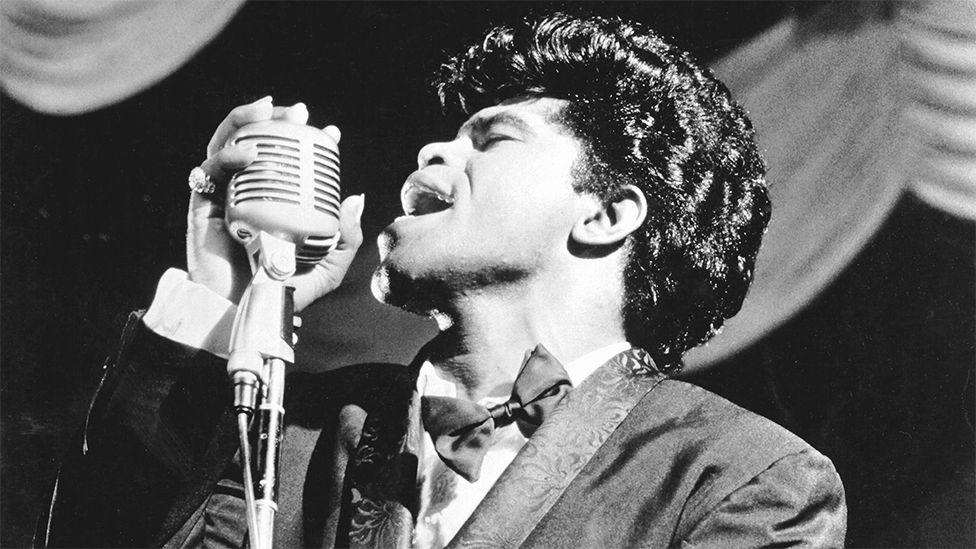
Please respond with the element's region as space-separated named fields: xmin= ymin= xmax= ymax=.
xmin=0 ymin=0 xmax=244 ymax=114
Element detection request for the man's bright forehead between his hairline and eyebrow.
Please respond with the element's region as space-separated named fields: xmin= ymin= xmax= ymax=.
xmin=458 ymin=97 xmax=569 ymax=135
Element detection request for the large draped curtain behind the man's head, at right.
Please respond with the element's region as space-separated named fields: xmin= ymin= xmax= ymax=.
xmin=687 ymin=0 xmax=976 ymax=370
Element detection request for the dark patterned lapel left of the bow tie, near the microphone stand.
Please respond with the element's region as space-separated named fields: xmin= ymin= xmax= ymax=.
xmin=344 ymin=366 xmax=423 ymax=548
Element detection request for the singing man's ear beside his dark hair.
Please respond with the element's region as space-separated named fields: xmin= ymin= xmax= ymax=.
xmin=570 ymin=185 xmax=647 ymax=246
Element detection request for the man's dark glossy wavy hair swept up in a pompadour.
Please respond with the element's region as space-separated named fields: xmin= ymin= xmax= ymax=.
xmin=434 ymin=13 xmax=770 ymax=372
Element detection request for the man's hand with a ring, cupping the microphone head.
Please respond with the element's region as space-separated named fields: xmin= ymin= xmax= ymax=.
xmin=187 ymin=97 xmax=363 ymax=310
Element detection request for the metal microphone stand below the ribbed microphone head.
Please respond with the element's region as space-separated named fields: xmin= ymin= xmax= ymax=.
xmin=227 ymin=231 xmax=297 ymax=549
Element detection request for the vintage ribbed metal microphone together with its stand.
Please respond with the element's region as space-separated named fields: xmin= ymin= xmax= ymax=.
xmin=225 ymin=120 xmax=339 ymax=549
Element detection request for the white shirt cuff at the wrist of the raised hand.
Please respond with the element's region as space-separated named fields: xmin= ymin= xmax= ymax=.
xmin=142 ymin=269 xmax=237 ymax=358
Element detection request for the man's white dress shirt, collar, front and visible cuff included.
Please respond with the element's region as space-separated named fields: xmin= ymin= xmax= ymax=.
xmin=143 ymin=269 xmax=630 ymax=548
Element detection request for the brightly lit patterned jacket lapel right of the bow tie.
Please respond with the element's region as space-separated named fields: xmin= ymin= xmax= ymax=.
xmin=448 ymin=349 xmax=666 ymax=547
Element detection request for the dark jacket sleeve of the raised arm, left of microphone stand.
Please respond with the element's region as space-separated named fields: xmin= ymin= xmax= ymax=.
xmin=34 ymin=313 xmax=237 ymax=547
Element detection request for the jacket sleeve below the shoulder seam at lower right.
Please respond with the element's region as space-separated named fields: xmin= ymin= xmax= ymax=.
xmin=681 ymin=449 xmax=847 ymax=548
